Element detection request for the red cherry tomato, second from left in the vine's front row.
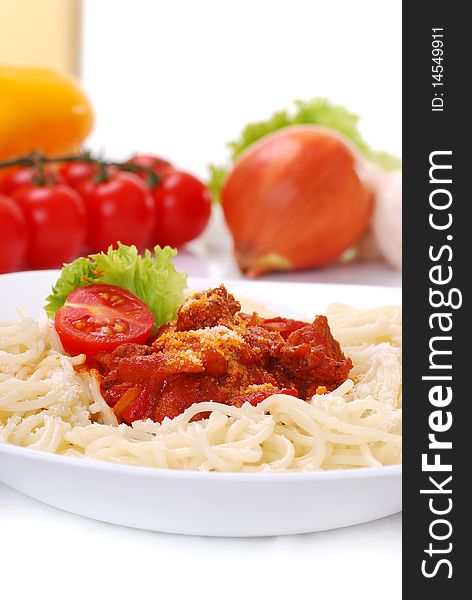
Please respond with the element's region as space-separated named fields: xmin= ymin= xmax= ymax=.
xmin=13 ymin=184 xmax=87 ymax=269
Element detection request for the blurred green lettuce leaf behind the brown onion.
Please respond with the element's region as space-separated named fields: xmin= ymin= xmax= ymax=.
xmin=208 ymin=98 xmax=401 ymax=202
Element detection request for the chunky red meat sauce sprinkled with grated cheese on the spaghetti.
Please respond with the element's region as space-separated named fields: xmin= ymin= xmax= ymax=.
xmin=96 ymin=286 xmax=352 ymax=422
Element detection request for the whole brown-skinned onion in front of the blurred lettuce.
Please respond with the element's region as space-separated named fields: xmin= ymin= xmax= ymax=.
xmin=222 ymin=125 xmax=372 ymax=277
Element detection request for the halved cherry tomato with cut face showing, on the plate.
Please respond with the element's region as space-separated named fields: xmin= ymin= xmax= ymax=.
xmin=54 ymin=284 xmax=154 ymax=359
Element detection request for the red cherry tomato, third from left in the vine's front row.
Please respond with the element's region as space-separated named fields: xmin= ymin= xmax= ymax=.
xmin=79 ymin=172 xmax=155 ymax=252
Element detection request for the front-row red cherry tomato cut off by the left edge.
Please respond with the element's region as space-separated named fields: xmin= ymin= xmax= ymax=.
xmin=0 ymin=194 xmax=26 ymax=273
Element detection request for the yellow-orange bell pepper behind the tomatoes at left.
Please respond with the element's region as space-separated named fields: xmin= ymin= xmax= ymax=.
xmin=0 ymin=65 xmax=93 ymax=160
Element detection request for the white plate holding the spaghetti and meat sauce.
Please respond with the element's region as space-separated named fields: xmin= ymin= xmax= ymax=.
xmin=0 ymin=271 xmax=402 ymax=536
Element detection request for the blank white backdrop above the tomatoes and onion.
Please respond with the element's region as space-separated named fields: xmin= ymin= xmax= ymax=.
xmin=82 ymin=0 xmax=401 ymax=176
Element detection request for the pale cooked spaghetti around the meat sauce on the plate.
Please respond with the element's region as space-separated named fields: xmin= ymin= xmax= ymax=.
xmin=0 ymin=304 xmax=402 ymax=472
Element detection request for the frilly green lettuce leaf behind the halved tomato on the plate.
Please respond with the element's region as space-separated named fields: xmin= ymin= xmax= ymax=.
xmin=44 ymin=242 xmax=187 ymax=326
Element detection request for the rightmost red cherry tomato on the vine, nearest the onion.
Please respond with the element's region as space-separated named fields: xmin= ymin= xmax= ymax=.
xmin=152 ymin=171 xmax=211 ymax=246
